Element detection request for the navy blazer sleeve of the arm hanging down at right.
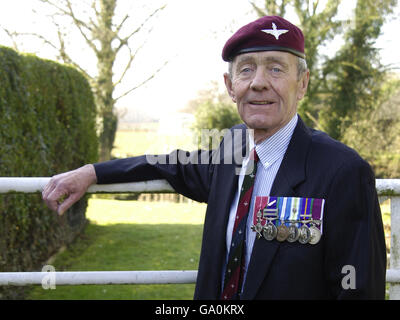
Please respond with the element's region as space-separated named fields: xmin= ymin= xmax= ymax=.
xmin=324 ymin=158 xmax=386 ymax=299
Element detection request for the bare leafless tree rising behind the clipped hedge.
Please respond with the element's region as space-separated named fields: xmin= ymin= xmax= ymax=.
xmin=6 ymin=0 xmax=166 ymax=161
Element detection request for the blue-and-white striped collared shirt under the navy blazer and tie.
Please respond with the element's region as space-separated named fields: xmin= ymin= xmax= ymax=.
xmin=226 ymin=114 xmax=298 ymax=288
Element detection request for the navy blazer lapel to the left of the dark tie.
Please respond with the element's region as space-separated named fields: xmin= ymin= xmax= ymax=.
xmin=194 ymin=125 xmax=247 ymax=300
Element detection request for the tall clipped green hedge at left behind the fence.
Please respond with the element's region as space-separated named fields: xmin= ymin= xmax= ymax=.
xmin=0 ymin=46 xmax=98 ymax=298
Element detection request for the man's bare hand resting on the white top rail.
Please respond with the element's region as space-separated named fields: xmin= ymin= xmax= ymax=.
xmin=42 ymin=164 xmax=97 ymax=215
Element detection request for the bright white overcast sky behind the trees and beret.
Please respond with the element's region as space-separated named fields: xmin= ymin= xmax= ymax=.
xmin=0 ymin=0 xmax=400 ymax=119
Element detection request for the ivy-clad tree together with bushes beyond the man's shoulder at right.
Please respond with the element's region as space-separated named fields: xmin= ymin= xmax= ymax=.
xmin=319 ymin=0 xmax=400 ymax=178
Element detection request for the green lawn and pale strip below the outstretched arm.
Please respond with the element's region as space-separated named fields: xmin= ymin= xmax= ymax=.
xmin=28 ymin=199 xmax=205 ymax=300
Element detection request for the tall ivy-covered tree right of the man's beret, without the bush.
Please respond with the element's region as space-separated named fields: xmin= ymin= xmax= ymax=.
xmin=320 ymin=0 xmax=397 ymax=140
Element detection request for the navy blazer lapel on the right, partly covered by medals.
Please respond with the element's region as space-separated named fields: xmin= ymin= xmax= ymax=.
xmin=241 ymin=117 xmax=311 ymax=300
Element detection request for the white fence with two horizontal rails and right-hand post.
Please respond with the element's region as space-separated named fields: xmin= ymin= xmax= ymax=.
xmin=0 ymin=177 xmax=400 ymax=300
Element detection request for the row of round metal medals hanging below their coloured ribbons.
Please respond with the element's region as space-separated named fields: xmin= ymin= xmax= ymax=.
xmin=251 ymin=210 xmax=321 ymax=244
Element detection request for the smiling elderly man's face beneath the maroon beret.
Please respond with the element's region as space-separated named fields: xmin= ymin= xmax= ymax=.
xmin=224 ymin=51 xmax=309 ymax=142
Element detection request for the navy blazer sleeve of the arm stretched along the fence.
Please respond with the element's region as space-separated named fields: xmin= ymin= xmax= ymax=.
xmin=94 ymin=150 xmax=213 ymax=202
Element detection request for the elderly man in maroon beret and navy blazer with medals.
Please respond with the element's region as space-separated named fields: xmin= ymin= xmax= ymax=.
xmin=43 ymin=16 xmax=386 ymax=300
